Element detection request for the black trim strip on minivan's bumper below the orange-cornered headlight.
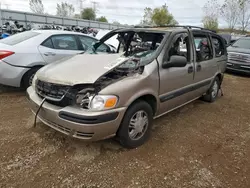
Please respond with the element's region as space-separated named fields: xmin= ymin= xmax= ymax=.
xmin=59 ymin=112 xmax=119 ymax=124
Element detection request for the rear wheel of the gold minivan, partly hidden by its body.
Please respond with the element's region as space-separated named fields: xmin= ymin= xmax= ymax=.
xmin=202 ymin=77 xmax=221 ymax=103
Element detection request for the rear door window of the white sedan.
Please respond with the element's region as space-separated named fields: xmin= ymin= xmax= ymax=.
xmin=50 ymin=35 xmax=78 ymax=50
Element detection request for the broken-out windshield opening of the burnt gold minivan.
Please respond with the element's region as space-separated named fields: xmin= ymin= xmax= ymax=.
xmin=96 ymin=30 xmax=166 ymax=61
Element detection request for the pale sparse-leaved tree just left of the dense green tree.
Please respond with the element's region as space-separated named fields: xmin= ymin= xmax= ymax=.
xmin=56 ymin=2 xmax=75 ymax=17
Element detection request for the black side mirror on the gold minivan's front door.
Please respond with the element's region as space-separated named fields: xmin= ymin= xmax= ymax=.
xmin=162 ymin=55 xmax=187 ymax=69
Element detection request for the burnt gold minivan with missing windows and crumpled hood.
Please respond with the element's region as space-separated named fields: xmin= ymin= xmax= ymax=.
xmin=27 ymin=26 xmax=227 ymax=148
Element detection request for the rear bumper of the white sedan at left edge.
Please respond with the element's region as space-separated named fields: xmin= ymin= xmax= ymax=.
xmin=0 ymin=60 xmax=29 ymax=87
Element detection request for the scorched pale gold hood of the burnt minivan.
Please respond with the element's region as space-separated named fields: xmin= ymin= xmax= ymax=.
xmin=36 ymin=54 xmax=128 ymax=86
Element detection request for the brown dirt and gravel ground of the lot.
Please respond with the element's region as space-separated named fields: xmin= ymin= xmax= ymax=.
xmin=0 ymin=75 xmax=250 ymax=188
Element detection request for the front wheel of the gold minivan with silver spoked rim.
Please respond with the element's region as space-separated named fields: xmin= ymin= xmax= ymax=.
xmin=117 ymin=100 xmax=153 ymax=149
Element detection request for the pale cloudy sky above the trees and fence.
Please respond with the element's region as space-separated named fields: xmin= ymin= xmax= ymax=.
xmin=0 ymin=0 xmax=225 ymax=26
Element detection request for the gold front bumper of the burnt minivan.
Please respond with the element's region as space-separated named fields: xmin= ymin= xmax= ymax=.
xmin=27 ymin=87 xmax=126 ymax=141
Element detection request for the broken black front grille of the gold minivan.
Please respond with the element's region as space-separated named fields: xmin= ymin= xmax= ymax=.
xmin=36 ymin=80 xmax=75 ymax=107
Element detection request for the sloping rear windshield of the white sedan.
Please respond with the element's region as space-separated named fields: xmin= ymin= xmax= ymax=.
xmin=0 ymin=31 xmax=40 ymax=45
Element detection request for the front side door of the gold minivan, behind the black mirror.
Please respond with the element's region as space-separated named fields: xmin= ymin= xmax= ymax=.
xmin=159 ymin=32 xmax=194 ymax=114
